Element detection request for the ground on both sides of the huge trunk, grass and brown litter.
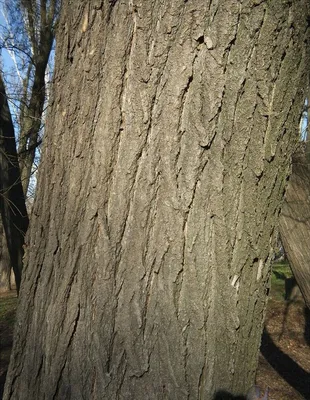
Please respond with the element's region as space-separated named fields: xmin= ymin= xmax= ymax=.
xmin=0 ymin=264 xmax=310 ymax=400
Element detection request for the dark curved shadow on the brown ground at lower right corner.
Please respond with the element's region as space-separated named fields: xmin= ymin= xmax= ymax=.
xmin=261 ymin=328 xmax=310 ymax=399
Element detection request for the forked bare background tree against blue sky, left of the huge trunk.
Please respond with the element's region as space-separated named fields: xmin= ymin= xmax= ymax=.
xmin=18 ymin=0 xmax=60 ymax=195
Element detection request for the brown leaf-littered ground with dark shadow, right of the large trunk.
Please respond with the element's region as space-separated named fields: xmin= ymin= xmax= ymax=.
xmin=257 ymin=300 xmax=310 ymax=400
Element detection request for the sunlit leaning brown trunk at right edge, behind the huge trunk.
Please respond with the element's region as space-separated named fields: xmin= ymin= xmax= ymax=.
xmin=280 ymin=145 xmax=310 ymax=308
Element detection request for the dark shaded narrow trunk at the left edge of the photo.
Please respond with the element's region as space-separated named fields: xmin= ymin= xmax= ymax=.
xmin=0 ymin=74 xmax=28 ymax=291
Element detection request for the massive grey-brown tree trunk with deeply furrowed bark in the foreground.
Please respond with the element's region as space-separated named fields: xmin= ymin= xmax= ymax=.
xmin=4 ymin=0 xmax=309 ymax=400
